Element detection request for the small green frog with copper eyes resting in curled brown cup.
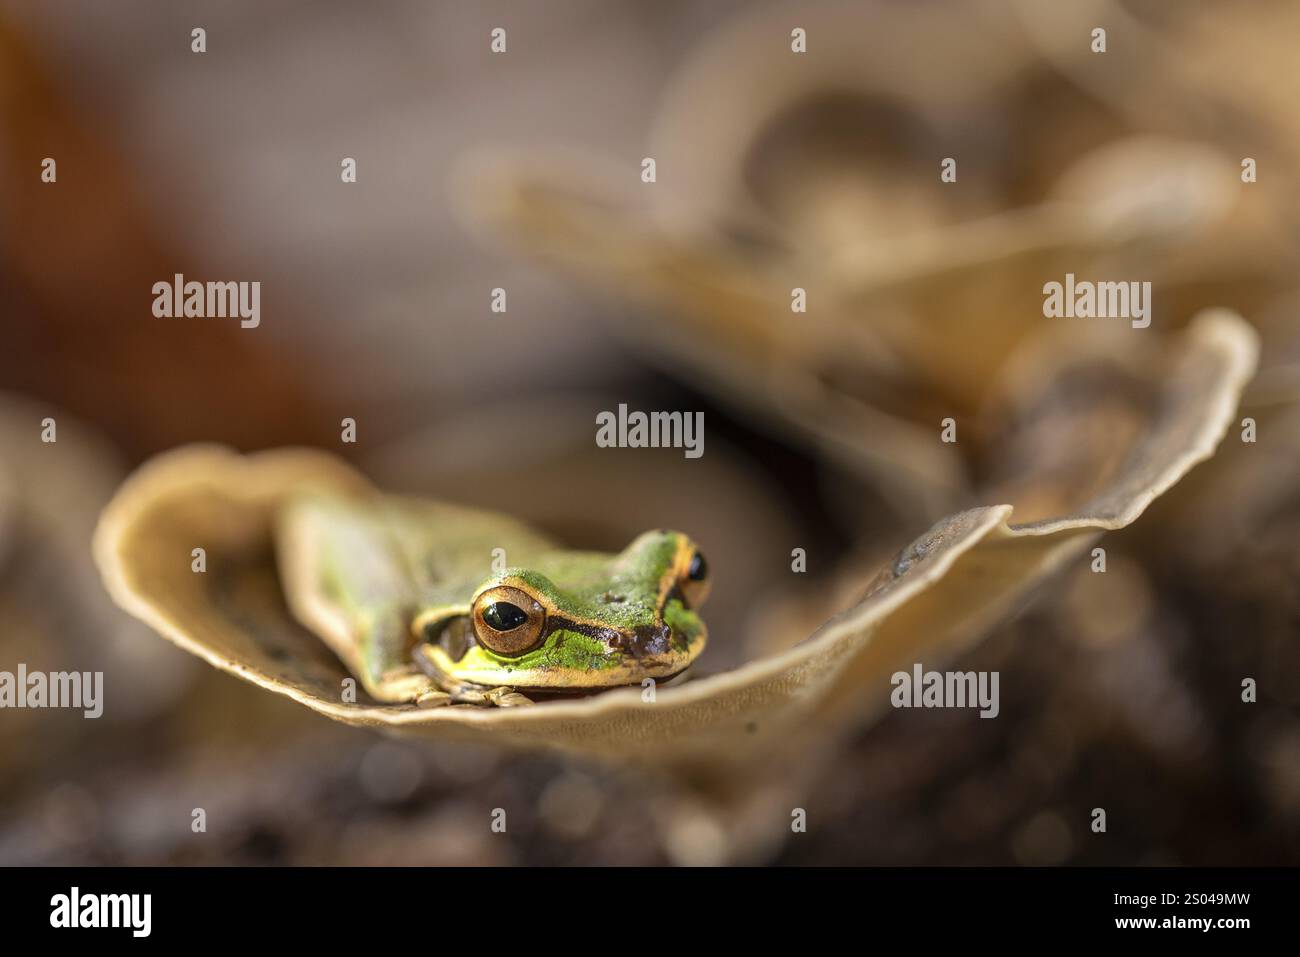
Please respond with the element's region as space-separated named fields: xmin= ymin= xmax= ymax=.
xmin=273 ymin=489 xmax=711 ymax=707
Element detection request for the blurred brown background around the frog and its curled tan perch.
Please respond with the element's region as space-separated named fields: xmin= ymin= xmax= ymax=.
xmin=0 ymin=0 xmax=1300 ymax=865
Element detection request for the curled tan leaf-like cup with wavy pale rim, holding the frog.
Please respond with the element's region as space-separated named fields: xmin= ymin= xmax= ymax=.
xmin=95 ymin=313 xmax=1255 ymax=776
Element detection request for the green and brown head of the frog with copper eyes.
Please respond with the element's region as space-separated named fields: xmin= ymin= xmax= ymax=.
xmin=412 ymin=531 xmax=709 ymax=692
